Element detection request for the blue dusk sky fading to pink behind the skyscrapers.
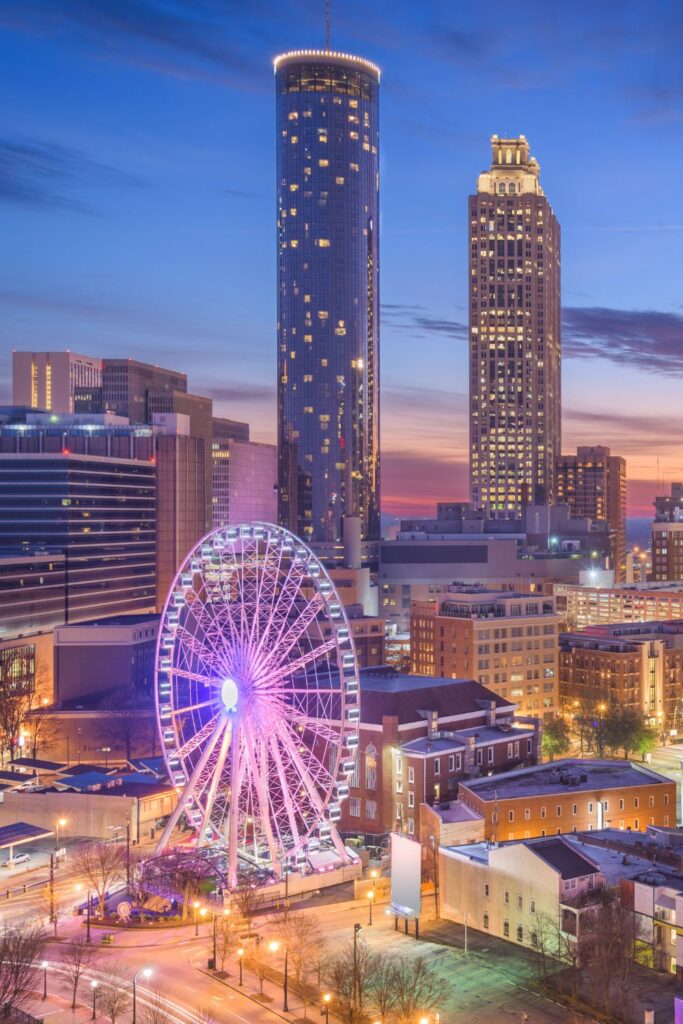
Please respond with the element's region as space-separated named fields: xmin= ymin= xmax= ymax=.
xmin=0 ymin=0 xmax=683 ymax=516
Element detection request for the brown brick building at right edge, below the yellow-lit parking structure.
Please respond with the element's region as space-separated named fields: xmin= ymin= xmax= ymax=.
xmin=559 ymin=622 xmax=683 ymax=735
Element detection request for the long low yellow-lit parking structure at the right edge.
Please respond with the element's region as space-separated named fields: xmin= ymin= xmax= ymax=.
xmin=553 ymin=582 xmax=683 ymax=630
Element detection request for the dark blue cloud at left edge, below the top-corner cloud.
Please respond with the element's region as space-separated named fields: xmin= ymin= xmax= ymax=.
xmin=0 ymin=136 xmax=142 ymax=212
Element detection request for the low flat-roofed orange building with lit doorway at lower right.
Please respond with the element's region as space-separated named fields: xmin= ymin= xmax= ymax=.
xmin=458 ymin=758 xmax=676 ymax=842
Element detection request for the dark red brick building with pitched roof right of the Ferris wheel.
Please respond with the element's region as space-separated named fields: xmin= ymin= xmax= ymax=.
xmin=340 ymin=667 xmax=540 ymax=838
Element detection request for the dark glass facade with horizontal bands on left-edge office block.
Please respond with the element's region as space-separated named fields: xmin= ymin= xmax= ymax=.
xmin=0 ymin=454 xmax=157 ymax=623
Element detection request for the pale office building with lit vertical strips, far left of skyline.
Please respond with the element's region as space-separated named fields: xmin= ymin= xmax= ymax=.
xmin=12 ymin=351 xmax=102 ymax=413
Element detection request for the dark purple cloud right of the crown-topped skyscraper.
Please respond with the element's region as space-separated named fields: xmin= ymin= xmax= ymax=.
xmin=562 ymin=306 xmax=683 ymax=376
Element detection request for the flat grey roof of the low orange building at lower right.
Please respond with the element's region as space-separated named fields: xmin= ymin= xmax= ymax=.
xmin=460 ymin=758 xmax=674 ymax=801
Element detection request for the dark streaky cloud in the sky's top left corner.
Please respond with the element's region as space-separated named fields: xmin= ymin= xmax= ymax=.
xmin=0 ymin=0 xmax=267 ymax=86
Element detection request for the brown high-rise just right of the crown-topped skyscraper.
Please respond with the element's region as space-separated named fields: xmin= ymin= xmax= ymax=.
xmin=555 ymin=444 xmax=626 ymax=583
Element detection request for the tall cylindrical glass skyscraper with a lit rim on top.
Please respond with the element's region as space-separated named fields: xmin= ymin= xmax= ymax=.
xmin=274 ymin=50 xmax=380 ymax=544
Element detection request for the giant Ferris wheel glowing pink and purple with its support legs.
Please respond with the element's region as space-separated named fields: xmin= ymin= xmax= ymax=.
xmin=156 ymin=523 xmax=360 ymax=888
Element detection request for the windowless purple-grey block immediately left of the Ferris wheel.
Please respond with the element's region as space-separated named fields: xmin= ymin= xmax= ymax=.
xmin=54 ymin=614 xmax=160 ymax=703
